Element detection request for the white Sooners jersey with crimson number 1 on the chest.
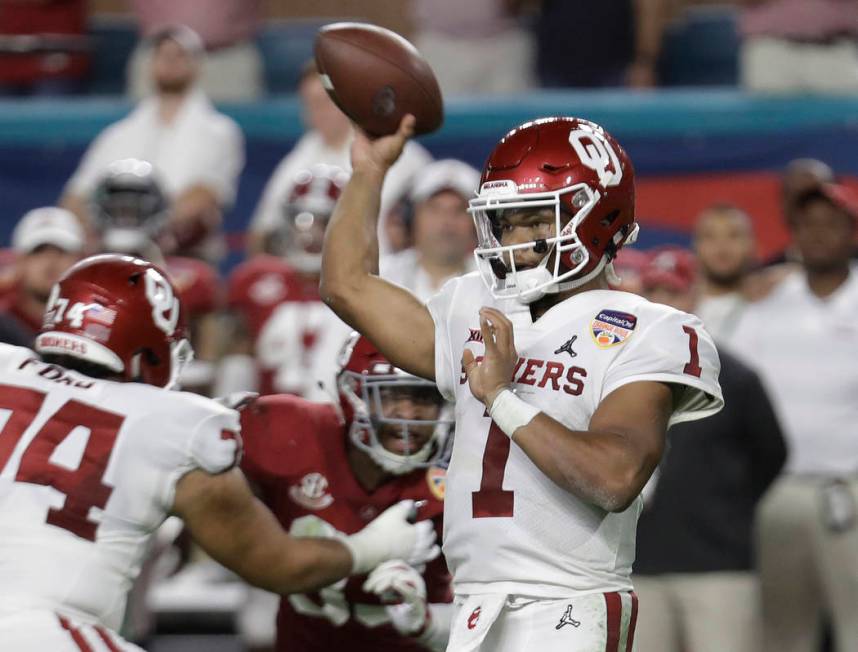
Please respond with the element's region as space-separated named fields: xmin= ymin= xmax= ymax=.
xmin=428 ymin=273 xmax=723 ymax=597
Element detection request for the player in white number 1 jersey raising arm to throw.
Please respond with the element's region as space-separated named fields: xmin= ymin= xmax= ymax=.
xmin=321 ymin=116 xmax=723 ymax=652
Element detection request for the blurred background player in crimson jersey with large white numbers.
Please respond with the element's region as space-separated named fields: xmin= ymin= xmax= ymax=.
xmin=224 ymin=165 xmax=351 ymax=400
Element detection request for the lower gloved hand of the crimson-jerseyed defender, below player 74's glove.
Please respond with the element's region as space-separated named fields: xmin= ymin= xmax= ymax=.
xmin=363 ymin=559 xmax=429 ymax=636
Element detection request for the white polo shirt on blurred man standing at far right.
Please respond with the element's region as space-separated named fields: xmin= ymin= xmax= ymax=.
xmin=728 ymin=269 xmax=858 ymax=475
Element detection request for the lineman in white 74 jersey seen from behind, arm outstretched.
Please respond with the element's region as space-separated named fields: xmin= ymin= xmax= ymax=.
xmin=0 ymin=255 xmax=442 ymax=652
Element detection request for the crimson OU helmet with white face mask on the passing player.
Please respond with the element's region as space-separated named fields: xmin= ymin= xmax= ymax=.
xmin=469 ymin=118 xmax=637 ymax=303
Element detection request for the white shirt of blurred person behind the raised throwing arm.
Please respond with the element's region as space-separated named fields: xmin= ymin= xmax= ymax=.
xmin=250 ymin=131 xmax=432 ymax=253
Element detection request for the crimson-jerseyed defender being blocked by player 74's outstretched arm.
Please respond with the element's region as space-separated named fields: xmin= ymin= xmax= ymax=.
xmin=241 ymin=334 xmax=451 ymax=652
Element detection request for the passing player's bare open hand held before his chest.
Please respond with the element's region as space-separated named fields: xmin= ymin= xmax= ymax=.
xmin=462 ymin=307 xmax=518 ymax=408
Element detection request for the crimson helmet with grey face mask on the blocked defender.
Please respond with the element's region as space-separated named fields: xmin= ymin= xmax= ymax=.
xmin=337 ymin=333 xmax=453 ymax=475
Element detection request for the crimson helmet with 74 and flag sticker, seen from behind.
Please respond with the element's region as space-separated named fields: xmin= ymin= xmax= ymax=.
xmin=36 ymin=254 xmax=193 ymax=388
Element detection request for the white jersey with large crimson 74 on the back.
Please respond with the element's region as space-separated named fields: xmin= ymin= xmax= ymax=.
xmin=0 ymin=344 xmax=240 ymax=629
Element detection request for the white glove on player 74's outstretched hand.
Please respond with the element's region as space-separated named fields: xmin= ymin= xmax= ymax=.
xmin=343 ymin=500 xmax=441 ymax=575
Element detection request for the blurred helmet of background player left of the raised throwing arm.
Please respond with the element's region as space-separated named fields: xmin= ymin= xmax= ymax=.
xmin=275 ymin=164 xmax=349 ymax=273
